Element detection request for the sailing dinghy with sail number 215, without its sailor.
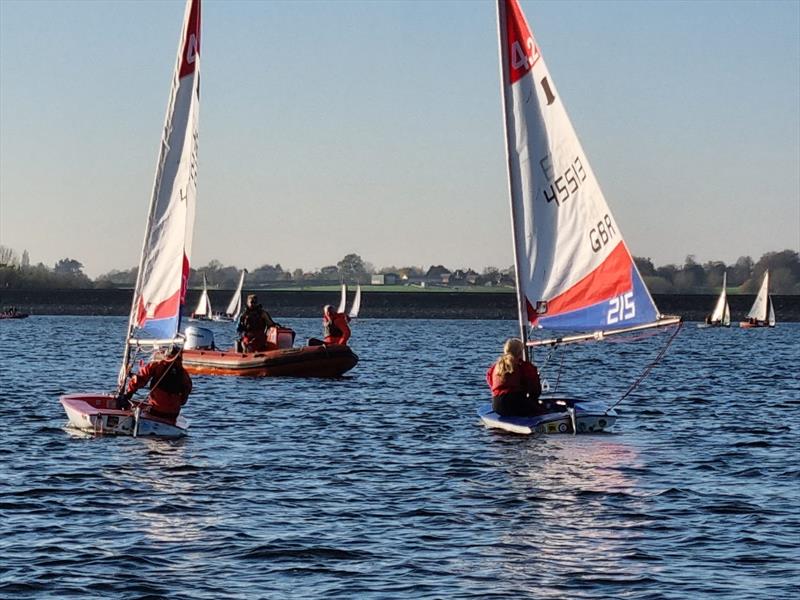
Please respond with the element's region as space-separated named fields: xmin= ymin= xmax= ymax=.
xmin=478 ymin=0 xmax=680 ymax=434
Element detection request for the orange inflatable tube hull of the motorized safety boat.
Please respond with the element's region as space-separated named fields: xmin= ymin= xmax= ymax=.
xmin=183 ymin=345 xmax=358 ymax=377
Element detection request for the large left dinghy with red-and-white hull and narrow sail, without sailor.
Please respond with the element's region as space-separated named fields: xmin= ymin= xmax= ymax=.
xmin=60 ymin=0 xmax=200 ymax=437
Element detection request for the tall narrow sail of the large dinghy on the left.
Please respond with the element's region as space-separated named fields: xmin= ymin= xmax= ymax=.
xmin=129 ymin=0 xmax=200 ymax=339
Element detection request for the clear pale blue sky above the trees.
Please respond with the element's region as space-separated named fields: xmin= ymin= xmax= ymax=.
xmin=0 ymin=0 xmax=800 ymax=277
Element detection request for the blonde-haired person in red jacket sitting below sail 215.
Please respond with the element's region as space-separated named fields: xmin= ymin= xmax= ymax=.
xmin=486 ymin=338 xmax=542 ymax=417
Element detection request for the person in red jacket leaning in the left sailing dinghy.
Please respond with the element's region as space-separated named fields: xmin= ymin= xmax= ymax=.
xmin=127 ymin=346 xmax=192 ymax=422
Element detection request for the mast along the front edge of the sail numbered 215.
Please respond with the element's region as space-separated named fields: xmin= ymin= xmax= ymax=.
xmin=497 ymin=0 xmax=528 ymax=360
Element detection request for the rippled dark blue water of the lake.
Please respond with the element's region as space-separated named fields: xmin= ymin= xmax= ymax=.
xmin=0 ymin=317 xmax=800 ymax=599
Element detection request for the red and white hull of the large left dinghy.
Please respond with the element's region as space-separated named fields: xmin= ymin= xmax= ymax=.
xmin=60 ymin=394 xmax=189 ymax=438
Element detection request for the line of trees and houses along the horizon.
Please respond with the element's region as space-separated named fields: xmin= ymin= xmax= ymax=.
xmin=0 ymin=246 xmax=800 ymax=294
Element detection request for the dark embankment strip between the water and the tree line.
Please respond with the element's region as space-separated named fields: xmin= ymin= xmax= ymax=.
xmin=0 ymin=289 xmax=800 ymax=322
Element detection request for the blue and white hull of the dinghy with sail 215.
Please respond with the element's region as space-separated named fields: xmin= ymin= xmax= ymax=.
xmin=478 ymin=398 xmax=618 ymax=435
